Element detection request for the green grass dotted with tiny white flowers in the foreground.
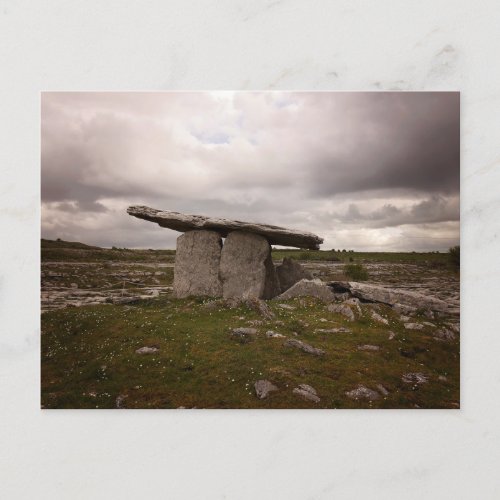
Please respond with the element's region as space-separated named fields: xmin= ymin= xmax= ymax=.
xmin=41 ymin=298 xmax=459 ymax=408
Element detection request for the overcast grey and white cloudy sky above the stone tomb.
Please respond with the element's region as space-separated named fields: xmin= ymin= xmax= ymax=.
xmin=41 ymin=92 xmax=460 ymax=251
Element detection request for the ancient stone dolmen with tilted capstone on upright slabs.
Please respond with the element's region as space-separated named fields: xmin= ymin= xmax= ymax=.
xmin=127 ymin=206 xmax=323 ymax=299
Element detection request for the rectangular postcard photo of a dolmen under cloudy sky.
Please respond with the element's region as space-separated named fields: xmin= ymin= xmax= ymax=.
xmin=41 ymin=91 xmax=460 ymax=410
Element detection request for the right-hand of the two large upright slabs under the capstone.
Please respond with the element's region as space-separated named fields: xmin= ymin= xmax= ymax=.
xmin=219 ymin=231 xmax=279 ymax=299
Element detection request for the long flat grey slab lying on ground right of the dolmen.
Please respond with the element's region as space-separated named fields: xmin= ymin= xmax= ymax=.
xmin=328 ymin=281 xmax=450 ymax=313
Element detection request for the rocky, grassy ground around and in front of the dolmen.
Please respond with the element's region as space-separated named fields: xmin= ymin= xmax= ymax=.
xmin=42 ymin=250 xmax=460 ymax=408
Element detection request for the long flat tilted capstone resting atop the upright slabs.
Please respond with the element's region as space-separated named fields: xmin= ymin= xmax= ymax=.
xmin=127 ymin=206 xmax=323 ymax=250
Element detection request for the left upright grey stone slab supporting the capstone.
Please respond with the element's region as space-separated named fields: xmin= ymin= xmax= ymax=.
xmin=174 ymin=230 xmax=222 ymax=298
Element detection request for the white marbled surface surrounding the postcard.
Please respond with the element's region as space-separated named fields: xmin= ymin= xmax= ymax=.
xmin=0 ymin=0 xmax=500 ymax=499
